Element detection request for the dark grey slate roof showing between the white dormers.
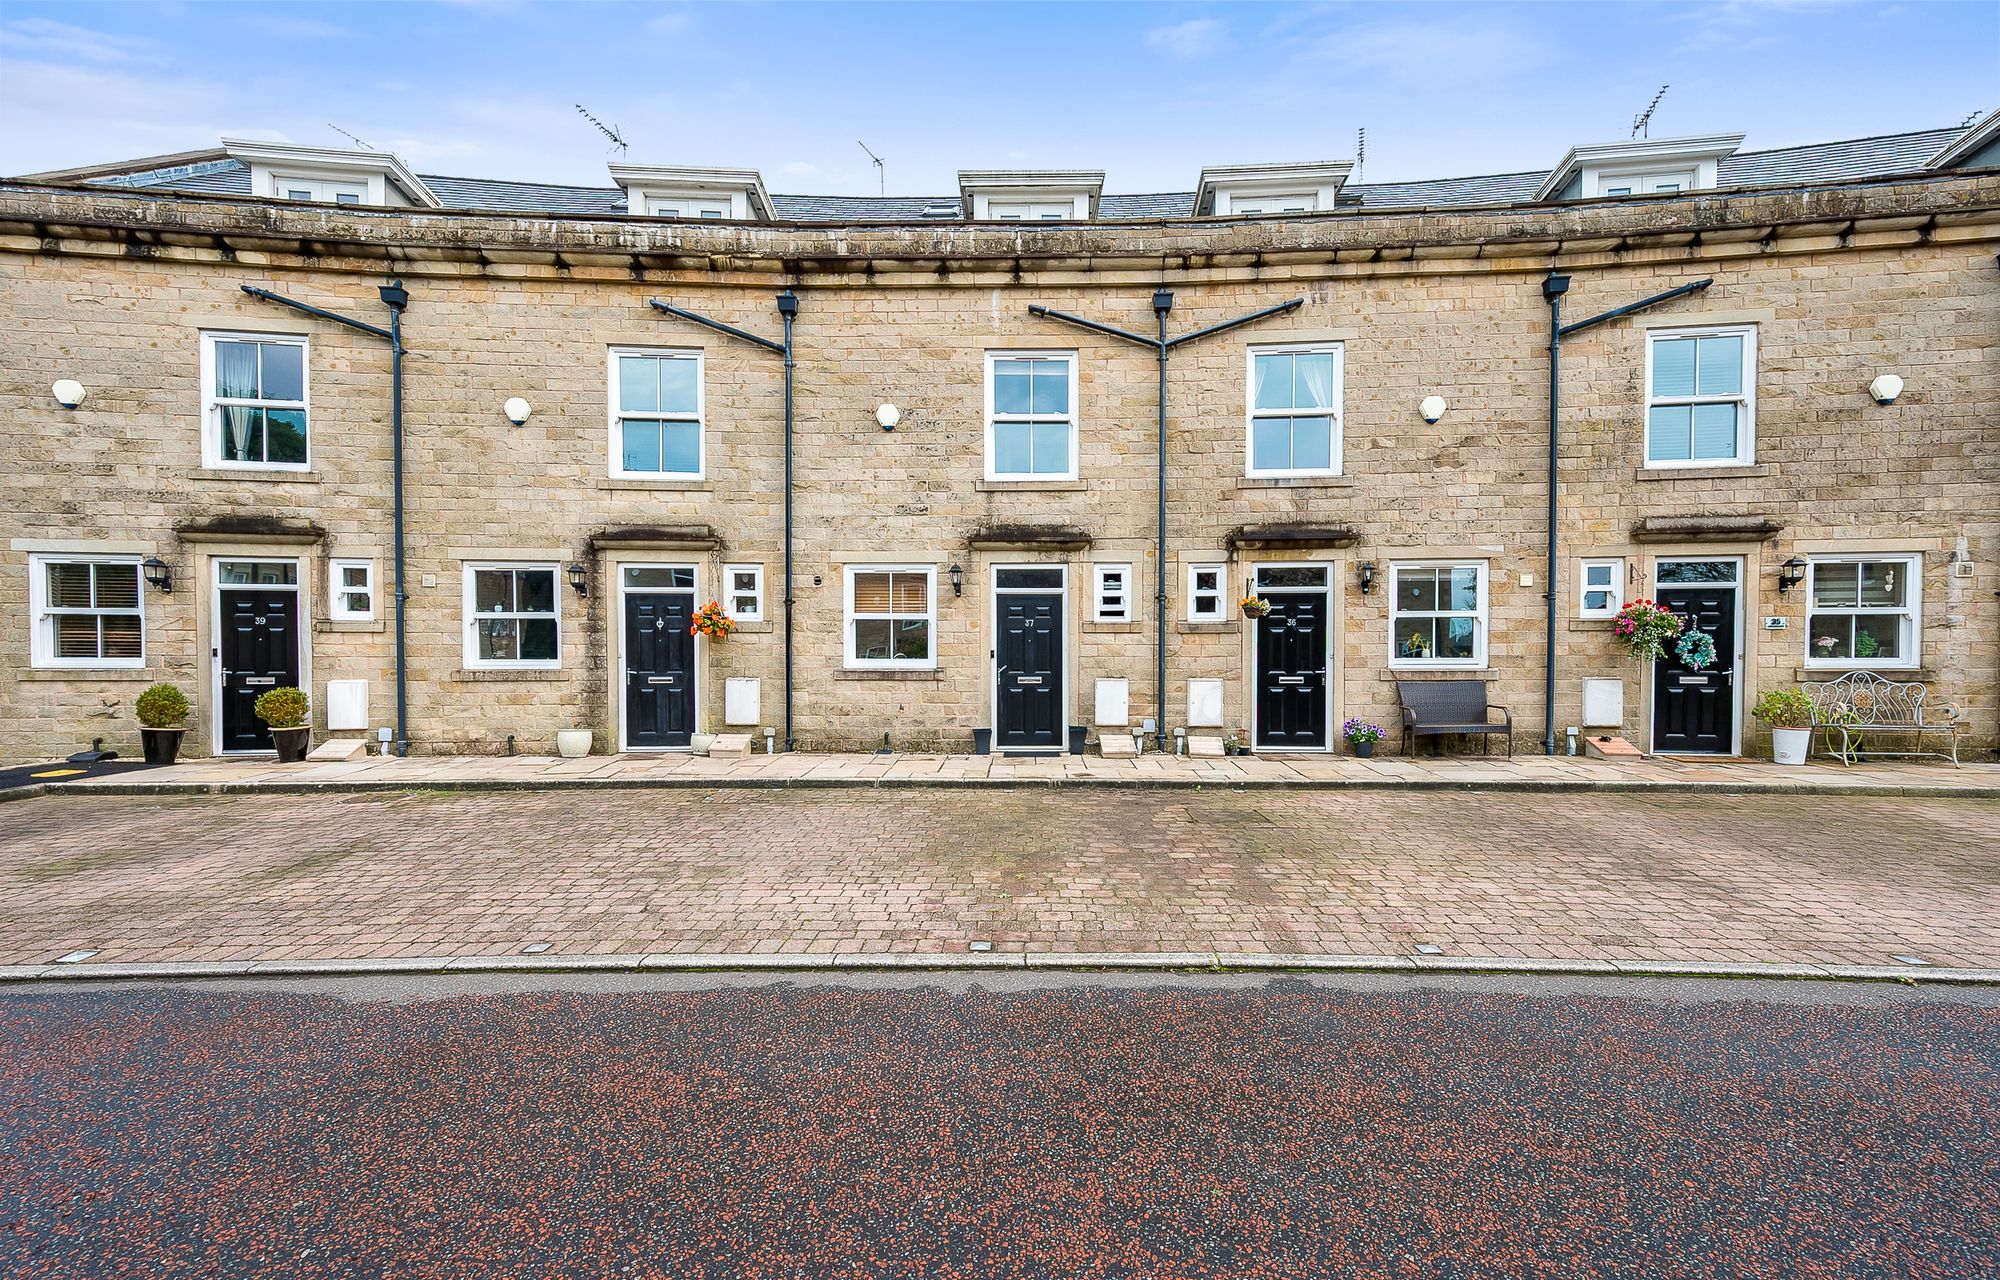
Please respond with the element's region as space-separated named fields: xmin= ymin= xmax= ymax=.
xmin=62 ymin=128 xmax=1964 ymax=222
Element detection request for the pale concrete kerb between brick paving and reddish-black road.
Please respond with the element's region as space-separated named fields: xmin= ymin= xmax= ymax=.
xmin=0 ymin=952 xmax=2000 ymax=986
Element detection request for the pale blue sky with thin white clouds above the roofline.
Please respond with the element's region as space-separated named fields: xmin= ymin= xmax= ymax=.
xmin=0 ymin=0 xmax=2000 ymax=194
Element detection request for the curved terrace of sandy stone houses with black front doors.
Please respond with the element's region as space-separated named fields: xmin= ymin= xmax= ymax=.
xmin=0 ymin=116 xmax=2000 ymax=758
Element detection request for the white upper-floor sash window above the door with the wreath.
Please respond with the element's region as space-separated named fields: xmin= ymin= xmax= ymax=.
xmin=1646 ymin=326 xmax=1756 ymax=468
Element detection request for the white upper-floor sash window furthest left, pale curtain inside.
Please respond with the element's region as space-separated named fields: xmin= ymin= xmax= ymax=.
xmin=202 ymin=334 xmax=312 ymax=472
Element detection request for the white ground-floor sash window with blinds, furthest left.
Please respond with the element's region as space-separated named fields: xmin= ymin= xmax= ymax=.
xmin=28 ymin=556 xmax=146 ymax=670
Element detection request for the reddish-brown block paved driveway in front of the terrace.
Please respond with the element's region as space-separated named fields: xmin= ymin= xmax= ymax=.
xmin=0 ymin=790 xmax=2000 ymax=968
